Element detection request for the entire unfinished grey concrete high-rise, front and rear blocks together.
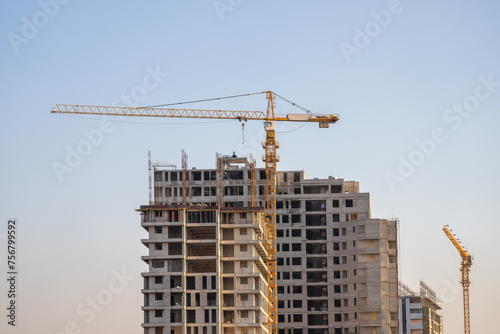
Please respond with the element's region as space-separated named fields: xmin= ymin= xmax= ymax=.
xmin=140 ymin=156 xmax=398 ymax=334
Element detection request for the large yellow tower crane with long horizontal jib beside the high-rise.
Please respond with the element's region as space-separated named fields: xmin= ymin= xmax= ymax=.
xmin=52 ymin=91 xmax=339 ymax=334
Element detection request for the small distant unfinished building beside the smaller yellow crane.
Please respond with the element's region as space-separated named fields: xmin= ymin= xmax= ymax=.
xmin=399 ymin=281 xmax=443 ymax=334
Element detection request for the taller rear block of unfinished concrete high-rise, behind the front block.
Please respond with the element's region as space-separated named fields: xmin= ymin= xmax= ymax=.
xmin=147 ymin=156 xmax=398 ymax=334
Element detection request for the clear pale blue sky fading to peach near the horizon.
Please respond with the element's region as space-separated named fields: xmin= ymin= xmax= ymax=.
xmin=0 ymin=0 xmax=500 ymax=334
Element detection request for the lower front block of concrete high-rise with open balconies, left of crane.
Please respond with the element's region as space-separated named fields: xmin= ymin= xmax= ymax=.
xmin=138 ymin=205 xmax=268 ymax=334
